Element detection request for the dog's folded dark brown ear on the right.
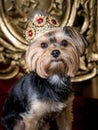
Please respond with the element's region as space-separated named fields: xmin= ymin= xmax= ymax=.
xmin=63 ymin=26 xmax=88 ymax=56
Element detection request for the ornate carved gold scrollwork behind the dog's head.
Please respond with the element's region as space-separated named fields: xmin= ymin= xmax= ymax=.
xmin=0 ymin=0 xmax=98 ymax=82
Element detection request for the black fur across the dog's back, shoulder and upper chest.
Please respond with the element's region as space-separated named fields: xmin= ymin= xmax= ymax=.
xmin=2 ymin=73 xmax=72 ymax=130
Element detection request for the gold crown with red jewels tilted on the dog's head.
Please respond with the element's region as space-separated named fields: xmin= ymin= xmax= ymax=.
xmin=24 ymin=14 xmax=59 ymax=43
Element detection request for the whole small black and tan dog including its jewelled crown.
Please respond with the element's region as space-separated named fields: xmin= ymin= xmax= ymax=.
xmin=2 ymin=14 xmax=87 ymax=130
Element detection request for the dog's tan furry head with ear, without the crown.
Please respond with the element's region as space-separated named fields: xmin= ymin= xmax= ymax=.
xmin=26 ymin=27 xmax=87 ymax=78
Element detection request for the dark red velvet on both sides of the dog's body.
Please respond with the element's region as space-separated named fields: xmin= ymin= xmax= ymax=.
xmin=0 ymin=78 xmax=98 ymax=130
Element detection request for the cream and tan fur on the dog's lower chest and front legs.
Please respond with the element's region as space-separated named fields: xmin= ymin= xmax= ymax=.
xmin=18 ymin=95 xmax=74 ymax=130
